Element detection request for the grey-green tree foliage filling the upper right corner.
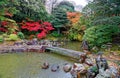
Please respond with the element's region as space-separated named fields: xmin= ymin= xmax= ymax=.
xmin=82 ymin=0 xmax=120 ymax=23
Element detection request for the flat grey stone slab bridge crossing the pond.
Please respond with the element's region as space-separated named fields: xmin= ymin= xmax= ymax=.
xmin=46 ymin=47 xmax=84 ymax=59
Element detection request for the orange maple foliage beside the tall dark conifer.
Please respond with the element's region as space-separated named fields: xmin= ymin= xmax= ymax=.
xmin=67 ymin=12 xmax=81 ymax=24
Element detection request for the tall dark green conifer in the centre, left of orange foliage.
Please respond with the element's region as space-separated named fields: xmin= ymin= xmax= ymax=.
xmin=51 ymin=1 xmax=74 ymax=33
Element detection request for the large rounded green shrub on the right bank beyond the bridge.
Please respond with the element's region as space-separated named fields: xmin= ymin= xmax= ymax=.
xmin=83 ymin=25 xmax=119 ymax=48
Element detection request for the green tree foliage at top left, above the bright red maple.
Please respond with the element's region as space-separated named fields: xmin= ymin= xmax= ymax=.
xmin=11 ymin=0 xmax=48 ymax=22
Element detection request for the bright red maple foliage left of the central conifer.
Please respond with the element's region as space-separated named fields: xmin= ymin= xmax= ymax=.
xmin=21 ymin=21 xmax=54 ymax=39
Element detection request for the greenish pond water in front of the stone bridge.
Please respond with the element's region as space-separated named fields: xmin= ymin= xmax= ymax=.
xmin=0 ymin=52 xmax=74 ymax=78
